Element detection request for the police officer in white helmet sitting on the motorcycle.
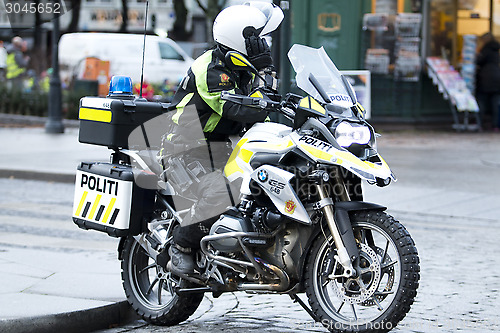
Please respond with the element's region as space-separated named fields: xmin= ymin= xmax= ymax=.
xmin=167 ymin=1 xmax=283 ymax=274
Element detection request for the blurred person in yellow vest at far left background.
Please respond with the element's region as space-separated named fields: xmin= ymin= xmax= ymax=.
xmin=5 ymin=36 xmax=30 ymax=90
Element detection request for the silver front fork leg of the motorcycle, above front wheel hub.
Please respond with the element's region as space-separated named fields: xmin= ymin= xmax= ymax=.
xmin=316 ymin=170 xmax=359 ymax=277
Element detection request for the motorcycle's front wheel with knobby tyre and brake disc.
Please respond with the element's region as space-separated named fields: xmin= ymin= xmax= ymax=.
xmin=305 ymin=211 xmax=420 ymax=333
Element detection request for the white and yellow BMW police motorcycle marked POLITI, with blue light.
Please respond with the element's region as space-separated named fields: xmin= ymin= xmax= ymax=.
xmin=73 ymin=45 xmax=419 ymax=332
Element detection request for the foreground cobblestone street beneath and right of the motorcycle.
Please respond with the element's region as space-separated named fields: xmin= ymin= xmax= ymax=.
xmin=94 ymin=213 xmax=500 ymax=333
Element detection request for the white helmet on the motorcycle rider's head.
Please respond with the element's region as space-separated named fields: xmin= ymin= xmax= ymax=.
xmin=213 ymin=1 xmax=284 ymax=55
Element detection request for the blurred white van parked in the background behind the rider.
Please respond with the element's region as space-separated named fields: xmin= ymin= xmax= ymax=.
xmin=59 ymin=32 xmax=193 ymax=84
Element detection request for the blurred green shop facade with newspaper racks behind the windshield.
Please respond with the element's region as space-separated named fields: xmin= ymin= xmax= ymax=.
xmin=290 ymin=0 xmax=500 ymax=122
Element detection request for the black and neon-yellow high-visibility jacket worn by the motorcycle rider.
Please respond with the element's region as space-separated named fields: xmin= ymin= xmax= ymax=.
xmin=170 ymin=48 xmax=267 ymax=140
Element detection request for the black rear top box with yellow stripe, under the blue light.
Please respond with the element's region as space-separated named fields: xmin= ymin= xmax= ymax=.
xmin=78 ymin=97 xmax=169 ymax=149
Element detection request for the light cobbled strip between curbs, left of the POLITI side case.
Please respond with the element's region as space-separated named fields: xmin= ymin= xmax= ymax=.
xmin=0 ymin=178 xmax=117 ymax=249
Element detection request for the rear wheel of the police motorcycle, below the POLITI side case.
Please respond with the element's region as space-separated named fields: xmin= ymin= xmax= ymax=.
xmin=121 ymin=237 xmax=203 ymax=326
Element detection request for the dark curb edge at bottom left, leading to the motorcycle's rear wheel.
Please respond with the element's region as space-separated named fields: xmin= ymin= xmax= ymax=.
xmin=0 ymin=301 xmax=139 ymax=333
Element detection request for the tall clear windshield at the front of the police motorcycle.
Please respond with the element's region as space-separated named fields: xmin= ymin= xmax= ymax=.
xmin=288 ymin=44 xmax=356 ymax=116
